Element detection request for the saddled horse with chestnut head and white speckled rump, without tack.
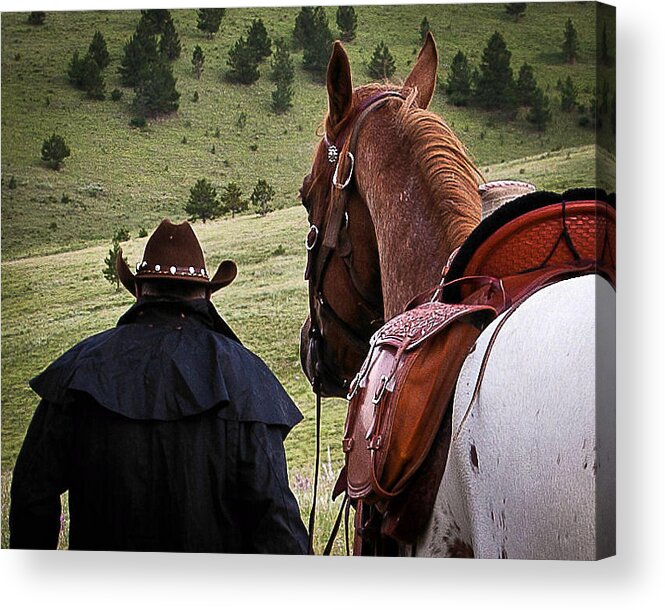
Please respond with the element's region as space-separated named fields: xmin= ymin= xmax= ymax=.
xmin=301 ymin=35 xmax=615 ymax=559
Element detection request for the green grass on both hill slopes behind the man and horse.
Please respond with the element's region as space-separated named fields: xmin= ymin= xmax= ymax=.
xmin=1 ymin=3 xmax=614 ymax=553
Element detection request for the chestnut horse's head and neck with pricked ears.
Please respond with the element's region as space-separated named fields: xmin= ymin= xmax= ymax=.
xmin=300 ymin=34 xmax=480 ymax=396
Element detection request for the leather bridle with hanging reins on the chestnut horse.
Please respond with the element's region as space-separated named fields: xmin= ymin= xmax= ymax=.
xmin=305 ymin=91 xmax=406 ymax=555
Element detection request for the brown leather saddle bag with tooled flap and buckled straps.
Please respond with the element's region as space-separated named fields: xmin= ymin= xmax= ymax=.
xmin=343 ymin=302 xmax=496 ymax=507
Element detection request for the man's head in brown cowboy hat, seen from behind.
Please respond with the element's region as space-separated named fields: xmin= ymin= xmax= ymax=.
xmin=116 ymin=218 xmax=237 ymax=299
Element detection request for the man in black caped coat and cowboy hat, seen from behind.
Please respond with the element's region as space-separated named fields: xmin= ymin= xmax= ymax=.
xmin=9 ymin=219 xmax=307 ymax=554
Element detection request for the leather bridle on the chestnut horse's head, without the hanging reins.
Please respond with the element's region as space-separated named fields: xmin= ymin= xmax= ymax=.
xmin=305 ymin=91 xmax=405 ymax=393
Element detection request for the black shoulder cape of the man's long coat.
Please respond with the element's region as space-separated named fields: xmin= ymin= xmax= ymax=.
xmin=30 ymin=298 xmax=302 ymax=435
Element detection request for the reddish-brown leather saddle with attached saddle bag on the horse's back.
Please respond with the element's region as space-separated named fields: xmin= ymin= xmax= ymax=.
xmin=336 ymin=189 xmax=616 ymax=554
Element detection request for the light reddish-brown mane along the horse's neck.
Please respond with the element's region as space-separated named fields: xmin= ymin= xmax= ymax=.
xmin=396 ymin=88 xmax=483 ymax=245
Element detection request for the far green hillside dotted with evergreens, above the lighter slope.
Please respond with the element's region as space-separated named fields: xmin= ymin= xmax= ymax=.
xmin=2 ymin=3 xmax=613 ymax=258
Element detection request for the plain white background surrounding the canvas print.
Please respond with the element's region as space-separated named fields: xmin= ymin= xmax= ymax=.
xmin=0 ymin=0 xmax=665 ymax=610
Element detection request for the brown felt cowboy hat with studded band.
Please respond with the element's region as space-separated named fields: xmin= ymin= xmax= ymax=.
xmin=115 ymin=218 xmax=238 ymax=295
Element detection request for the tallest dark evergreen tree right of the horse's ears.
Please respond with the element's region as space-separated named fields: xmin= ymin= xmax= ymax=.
xmin=476 ymin=32 xmax=515 ymax=109
